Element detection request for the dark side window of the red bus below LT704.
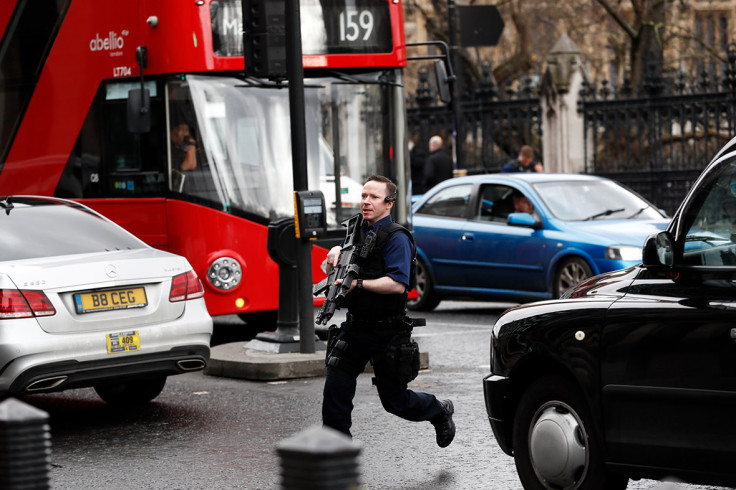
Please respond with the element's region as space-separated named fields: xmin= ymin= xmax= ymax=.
xmin=54 ymin=81 xmax=165 ymax=198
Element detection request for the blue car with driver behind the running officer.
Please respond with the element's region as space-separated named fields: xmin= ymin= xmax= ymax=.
xmin=409 ymin=173 xmax=669 ymax=310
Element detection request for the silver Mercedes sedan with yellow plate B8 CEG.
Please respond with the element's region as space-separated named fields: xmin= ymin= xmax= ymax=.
xmin=0 ymin=196 xmax=212 ymax=405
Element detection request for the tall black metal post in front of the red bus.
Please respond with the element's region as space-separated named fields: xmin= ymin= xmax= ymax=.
xmin=286 ymin=0 xmax=315 ymax=354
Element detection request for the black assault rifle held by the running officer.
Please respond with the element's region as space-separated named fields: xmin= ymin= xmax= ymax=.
xmin=312 ymin=214 xmax=376 ymax=325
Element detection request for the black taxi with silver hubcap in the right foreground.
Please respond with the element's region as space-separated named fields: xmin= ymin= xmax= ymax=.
xmin=483 ymin=138 xmax=736 ymax=489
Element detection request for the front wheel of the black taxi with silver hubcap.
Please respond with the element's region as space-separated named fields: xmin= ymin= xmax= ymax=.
xmin=513 ymin=376 xmax=628 ymax=490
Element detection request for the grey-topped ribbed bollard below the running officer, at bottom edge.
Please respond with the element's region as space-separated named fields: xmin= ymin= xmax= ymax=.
xmin=276 ymin=426 xmax=361 ymax=490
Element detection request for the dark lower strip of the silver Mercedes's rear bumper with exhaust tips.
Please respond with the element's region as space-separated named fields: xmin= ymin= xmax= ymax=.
xmin=8 ymin=345 xmax=210 ymax=395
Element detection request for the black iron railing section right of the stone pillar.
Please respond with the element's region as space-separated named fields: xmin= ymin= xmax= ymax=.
xmin=579 ymin=45 xmax=736 ymax=214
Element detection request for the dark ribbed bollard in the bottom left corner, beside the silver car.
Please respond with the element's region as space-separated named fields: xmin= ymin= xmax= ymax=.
xmin=0 ymin=398 xmax=51 ymax=490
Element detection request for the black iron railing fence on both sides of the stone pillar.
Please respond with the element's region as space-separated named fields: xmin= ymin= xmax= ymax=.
xmin=408 ymin=44 xmax=736 ymax=214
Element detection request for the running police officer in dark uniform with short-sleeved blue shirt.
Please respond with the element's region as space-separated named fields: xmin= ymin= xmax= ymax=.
xmin=322 ymin=176 xmax=455 ymax=447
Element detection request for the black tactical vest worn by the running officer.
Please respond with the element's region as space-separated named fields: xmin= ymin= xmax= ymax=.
xmin=345 ymin=223 xmax=416 ymax=321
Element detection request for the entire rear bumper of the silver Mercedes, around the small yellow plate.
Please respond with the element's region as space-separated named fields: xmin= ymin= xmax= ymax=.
xmin=0 ymin=300 xmax=212 ymax=395
